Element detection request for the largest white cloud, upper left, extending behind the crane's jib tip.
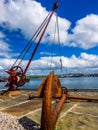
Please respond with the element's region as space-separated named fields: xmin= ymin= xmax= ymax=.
xmin=0 ymin=0 xmax=70 ymax=43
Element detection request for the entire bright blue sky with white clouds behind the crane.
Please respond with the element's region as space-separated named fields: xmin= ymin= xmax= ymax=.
xmin=0 ymin=0 xmax=98 ymax=75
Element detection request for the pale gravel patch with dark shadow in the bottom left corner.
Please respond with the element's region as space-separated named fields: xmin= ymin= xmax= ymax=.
xmin=0 ymin=112 xmax=40 ymax=130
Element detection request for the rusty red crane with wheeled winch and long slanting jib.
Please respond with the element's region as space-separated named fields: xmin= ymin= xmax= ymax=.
xmin=6 ymin=1 xmax=58 ymax=90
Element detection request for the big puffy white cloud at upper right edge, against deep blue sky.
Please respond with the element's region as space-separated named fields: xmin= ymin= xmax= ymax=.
xmin=70 ymin=14 xmax=98 ymax=49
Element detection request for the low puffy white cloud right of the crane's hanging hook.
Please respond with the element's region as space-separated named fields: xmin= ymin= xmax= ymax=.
xmin=63 ymin=53 xmax=98 ymax=69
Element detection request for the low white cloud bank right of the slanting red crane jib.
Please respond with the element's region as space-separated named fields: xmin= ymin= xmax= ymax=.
xmin=27 ymin=53 xmax=98 ymax=73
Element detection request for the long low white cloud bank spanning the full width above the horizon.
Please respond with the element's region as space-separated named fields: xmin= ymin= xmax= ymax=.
xmin=0 ymin=53 xmax=98 ymax=75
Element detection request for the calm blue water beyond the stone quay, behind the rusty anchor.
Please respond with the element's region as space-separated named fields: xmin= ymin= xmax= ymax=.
xmin=0 ymin=77 xmax=98 ymax=89
